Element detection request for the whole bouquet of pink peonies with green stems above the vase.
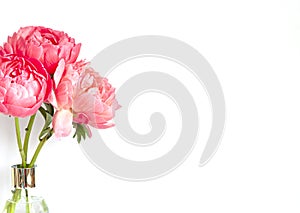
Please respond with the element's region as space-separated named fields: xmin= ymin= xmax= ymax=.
xmin=0 ymin=26 xmax=119 ymax=168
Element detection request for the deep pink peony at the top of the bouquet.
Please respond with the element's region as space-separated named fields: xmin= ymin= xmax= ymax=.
xmin=0 ymin=26 xmax=81 ymax=74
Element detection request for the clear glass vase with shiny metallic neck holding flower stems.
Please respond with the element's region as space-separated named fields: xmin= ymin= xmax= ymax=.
xmin=2 ymin=165 xmax=49 ymax=213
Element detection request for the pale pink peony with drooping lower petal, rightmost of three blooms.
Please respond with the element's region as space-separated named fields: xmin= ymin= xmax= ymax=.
xmin=49 ymin=61 xmax=119 ymax=137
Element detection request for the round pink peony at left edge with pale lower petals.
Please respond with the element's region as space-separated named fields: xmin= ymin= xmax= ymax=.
xmin=0 ymin=55 xmax=52 ymax=117
